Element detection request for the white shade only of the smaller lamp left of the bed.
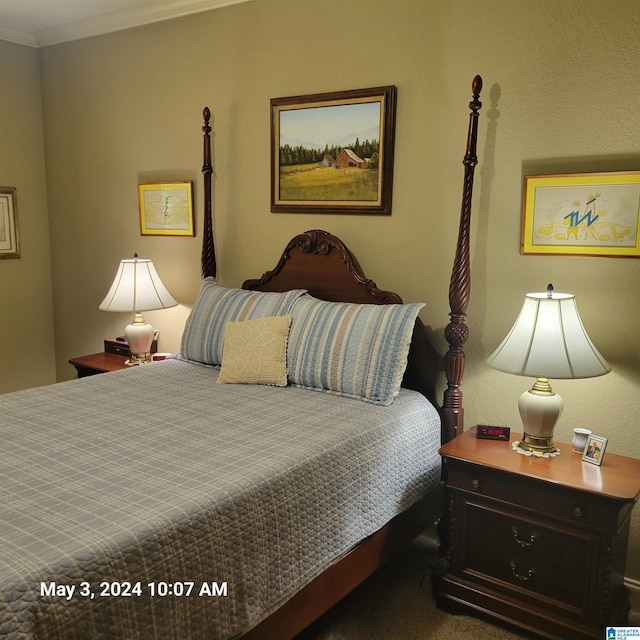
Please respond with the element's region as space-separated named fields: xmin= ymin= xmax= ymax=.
xmin=98 ymin=256 xmax=178 ymax=311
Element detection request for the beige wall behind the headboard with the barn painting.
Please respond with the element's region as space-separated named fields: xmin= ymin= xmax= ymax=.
xmin=15 ymin=0 xmax=640 ymax=579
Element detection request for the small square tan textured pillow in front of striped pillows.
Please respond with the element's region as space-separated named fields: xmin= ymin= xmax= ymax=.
xmin=218 ymin=315 xmax=291 ymax=387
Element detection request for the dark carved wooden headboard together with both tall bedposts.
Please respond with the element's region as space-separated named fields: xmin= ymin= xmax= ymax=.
xmin=202 ymin=76 xmax=482 ymax=442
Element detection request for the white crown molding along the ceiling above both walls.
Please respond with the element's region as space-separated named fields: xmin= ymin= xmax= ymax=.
xmin=0 ymin=0 xmax=251 ymax=47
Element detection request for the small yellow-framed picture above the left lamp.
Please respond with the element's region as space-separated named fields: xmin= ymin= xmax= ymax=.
xmin=138 ymin=181 xmax=195 ymax=236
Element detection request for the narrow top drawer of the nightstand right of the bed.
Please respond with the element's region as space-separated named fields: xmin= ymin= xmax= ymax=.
xmin=448 ymin=462 xmax=620 ymax=533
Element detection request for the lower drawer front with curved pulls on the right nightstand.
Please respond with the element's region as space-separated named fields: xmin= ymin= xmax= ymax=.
xmin=454 ymin=497 xmax=599 ymax=615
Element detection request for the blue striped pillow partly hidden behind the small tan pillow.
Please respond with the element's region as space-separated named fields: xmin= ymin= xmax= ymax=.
xmin=180 ymin=278 xmax=305 ymax=365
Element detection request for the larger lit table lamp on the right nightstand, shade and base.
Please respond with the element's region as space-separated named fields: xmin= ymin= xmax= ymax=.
xmin=487 ymin=285 xmax=611 ymax=457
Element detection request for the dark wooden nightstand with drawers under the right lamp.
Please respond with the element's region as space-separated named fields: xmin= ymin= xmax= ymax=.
xmin=436 ymin=428 xmax=640 ymax=640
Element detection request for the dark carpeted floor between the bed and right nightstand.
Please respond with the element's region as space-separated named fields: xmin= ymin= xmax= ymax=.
xmin=296 ymin=546 xmax=640 ymax=640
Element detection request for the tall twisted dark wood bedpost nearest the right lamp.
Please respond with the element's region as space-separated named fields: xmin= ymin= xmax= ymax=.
xmin=442 ymin=76 xmax=482 ymax=440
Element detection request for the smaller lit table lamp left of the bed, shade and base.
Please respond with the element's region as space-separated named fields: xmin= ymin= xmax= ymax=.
xmin=98 ymin=253 xmax=178 ymax=365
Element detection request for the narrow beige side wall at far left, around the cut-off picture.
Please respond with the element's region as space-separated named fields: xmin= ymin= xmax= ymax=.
xmin=0 ymin=41 xmax=55 ymax=393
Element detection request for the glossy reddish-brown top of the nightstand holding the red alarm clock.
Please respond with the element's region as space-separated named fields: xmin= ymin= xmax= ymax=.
xmin=440 ymin=427 xmax=640 ymax=501
